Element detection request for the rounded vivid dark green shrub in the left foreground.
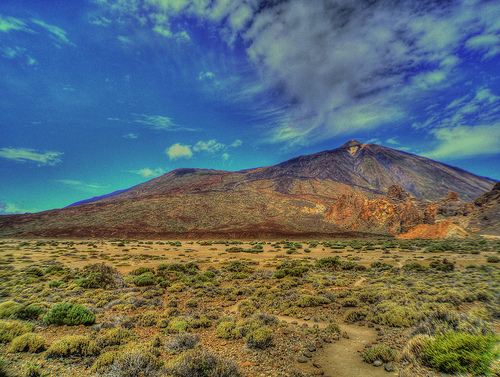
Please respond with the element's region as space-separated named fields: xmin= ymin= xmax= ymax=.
xmin=43 ymin=302 xmax=95 ymax=326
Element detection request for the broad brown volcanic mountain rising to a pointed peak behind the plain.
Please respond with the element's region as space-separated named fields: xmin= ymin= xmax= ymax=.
xmin=0 ymin=140 xmax=496 ymax=238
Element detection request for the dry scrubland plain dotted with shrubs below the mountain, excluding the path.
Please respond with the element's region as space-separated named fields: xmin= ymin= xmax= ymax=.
xmin=0 ymin=238 xmax=500 ymax=377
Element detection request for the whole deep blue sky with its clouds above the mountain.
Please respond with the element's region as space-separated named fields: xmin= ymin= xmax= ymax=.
xmin=0 ymin=0 xmax=500 ymax=214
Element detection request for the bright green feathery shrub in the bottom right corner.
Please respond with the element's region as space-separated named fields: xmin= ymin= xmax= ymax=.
xmin=423 ymin=332 xmax=500 ymax=375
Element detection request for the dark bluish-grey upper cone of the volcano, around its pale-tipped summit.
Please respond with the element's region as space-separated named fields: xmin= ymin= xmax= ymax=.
xmin=244 ymin=140 xmax=495 ymax=201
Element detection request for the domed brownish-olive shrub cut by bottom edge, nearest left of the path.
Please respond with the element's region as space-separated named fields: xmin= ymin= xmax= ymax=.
xmin=166 ymin=349 xmax=241 ymax=377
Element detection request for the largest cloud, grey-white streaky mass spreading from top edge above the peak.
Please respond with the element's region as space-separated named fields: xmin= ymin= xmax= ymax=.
xmin=95 ymin=0 xmax=500 ymax=145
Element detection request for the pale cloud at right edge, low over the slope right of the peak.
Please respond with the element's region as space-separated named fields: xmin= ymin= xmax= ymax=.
xmin=422 ymin=123 xmax=500 ymax=159
